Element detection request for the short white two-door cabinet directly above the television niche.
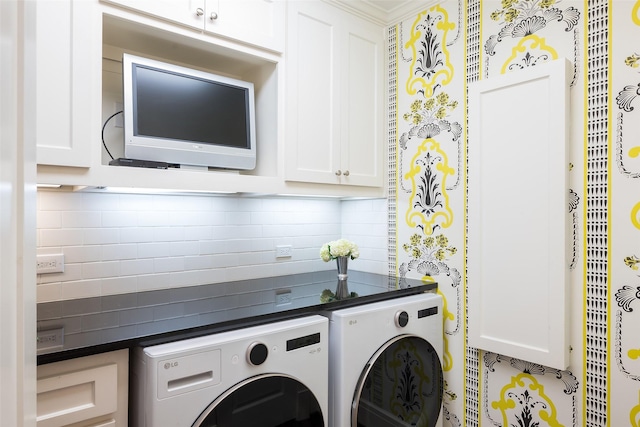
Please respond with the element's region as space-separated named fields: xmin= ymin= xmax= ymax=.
xmin=103 ymin=0 xmax=286 ymax=52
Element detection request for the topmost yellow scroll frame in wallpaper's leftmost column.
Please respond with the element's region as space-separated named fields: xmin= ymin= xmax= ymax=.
xmin=404 ymin=6 xmax=455 ymax=98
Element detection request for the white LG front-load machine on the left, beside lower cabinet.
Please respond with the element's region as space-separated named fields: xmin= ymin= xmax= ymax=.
xmin=132 ymin=315 xmax=328 ymax=427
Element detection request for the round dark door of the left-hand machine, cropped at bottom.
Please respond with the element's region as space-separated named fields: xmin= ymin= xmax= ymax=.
xmin=188 ymin=374 xmax=324 ymax=427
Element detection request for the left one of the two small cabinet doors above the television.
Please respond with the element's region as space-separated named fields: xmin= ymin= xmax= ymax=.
xmin=102 ymin=0 xmax=205 ymax=30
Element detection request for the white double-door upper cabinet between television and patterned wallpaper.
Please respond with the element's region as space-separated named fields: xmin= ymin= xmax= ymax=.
xmin=285 ymin=1 xmax=385 ymax=187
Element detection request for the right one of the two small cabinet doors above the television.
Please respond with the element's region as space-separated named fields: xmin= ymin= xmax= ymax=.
xmin=204 ymin=0 xmax=286 ymax=52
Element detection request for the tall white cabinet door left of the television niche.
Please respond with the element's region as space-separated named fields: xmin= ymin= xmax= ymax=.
xmin=32 ymin=0 xmax=100 ymax=167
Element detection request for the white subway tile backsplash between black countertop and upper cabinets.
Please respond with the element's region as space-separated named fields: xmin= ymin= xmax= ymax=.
xmin=37 ymin=192 xmax=388 ymax=306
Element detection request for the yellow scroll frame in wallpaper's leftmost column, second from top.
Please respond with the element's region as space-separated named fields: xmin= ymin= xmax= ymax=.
xmin=404 ymin=138 xmax=455 ymax=235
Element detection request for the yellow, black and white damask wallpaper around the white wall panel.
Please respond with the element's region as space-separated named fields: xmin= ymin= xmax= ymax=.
xmin=389 ymin=0 xmax=640 ymax=427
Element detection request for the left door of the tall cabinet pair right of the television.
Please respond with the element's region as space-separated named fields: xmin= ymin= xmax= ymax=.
xmin=285 ymin=1 xmax=341 ymax=184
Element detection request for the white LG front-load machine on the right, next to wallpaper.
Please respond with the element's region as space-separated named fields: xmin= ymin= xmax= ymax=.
xmin=325 ymin=293 xmax=443 ymax=427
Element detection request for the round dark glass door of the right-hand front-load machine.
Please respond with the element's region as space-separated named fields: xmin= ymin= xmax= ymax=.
xmin=351 ymin=335 xmax=443 ymax=427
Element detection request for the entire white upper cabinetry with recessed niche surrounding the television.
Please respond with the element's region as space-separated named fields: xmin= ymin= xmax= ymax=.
xmin=37 ymin=0 xmax=385 ymax=197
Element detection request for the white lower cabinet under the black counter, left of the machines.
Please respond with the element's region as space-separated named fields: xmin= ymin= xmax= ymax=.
xmin=36 ymin=349 xmax=129 ymax=427
